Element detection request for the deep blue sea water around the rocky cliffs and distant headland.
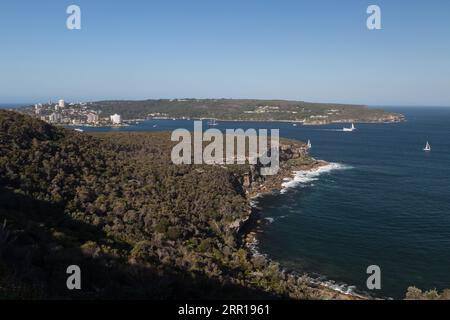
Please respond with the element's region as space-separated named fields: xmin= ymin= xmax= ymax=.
xmin=82 ymin=108 xmax=450 ymax=298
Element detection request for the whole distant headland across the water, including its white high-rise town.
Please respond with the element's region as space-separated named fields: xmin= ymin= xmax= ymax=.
xmin=16 ymin=99 xmax=404 ymax=125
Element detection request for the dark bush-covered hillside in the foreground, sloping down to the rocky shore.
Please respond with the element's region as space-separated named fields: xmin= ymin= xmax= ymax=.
xmin=0 ymin=111 xmax=348 ymax=299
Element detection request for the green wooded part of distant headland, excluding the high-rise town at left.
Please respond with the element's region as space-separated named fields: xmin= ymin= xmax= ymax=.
xmin=84 ymin=99 xmax=403 ymax=124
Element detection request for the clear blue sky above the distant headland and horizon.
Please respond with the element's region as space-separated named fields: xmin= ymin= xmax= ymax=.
xmin=0 ymin=0 xmax=450 ymax=106
